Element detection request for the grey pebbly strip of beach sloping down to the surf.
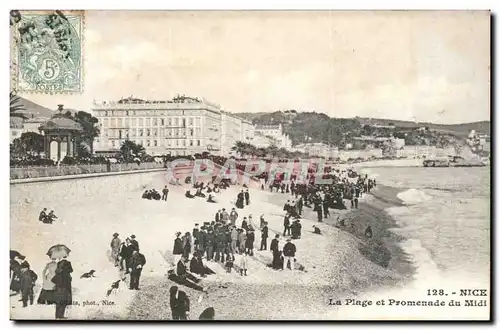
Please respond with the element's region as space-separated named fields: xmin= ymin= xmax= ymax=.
xmin=94 ymin=185 xmax=415 ymax=320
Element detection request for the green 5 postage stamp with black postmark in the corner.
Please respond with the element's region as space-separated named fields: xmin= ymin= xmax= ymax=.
xmin=11 ymin=10 xmax=84 ymax=94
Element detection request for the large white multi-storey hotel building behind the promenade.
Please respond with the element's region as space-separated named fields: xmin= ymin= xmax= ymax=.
xmin=92 ymin=96 xmax=254 ymax=156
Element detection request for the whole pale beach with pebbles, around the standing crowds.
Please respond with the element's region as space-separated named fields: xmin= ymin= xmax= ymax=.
xmin=11 ymin=166 xmax=412 ymax=320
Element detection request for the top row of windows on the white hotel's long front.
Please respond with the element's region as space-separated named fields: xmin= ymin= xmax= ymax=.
xmin=102 ymin=117 xmax=201 ymax=128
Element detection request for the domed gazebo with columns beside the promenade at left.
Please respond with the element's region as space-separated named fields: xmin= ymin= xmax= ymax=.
xmin=39 ymin=104 xmax=83 ymax=160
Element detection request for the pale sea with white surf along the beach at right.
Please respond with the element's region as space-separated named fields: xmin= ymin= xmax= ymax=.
xmin=346 ymin=167 xmax=492 ymax=320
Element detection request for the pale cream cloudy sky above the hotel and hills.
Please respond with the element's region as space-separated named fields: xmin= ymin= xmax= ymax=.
xmin=18 ymin=11 xmax=490 ymax=124
